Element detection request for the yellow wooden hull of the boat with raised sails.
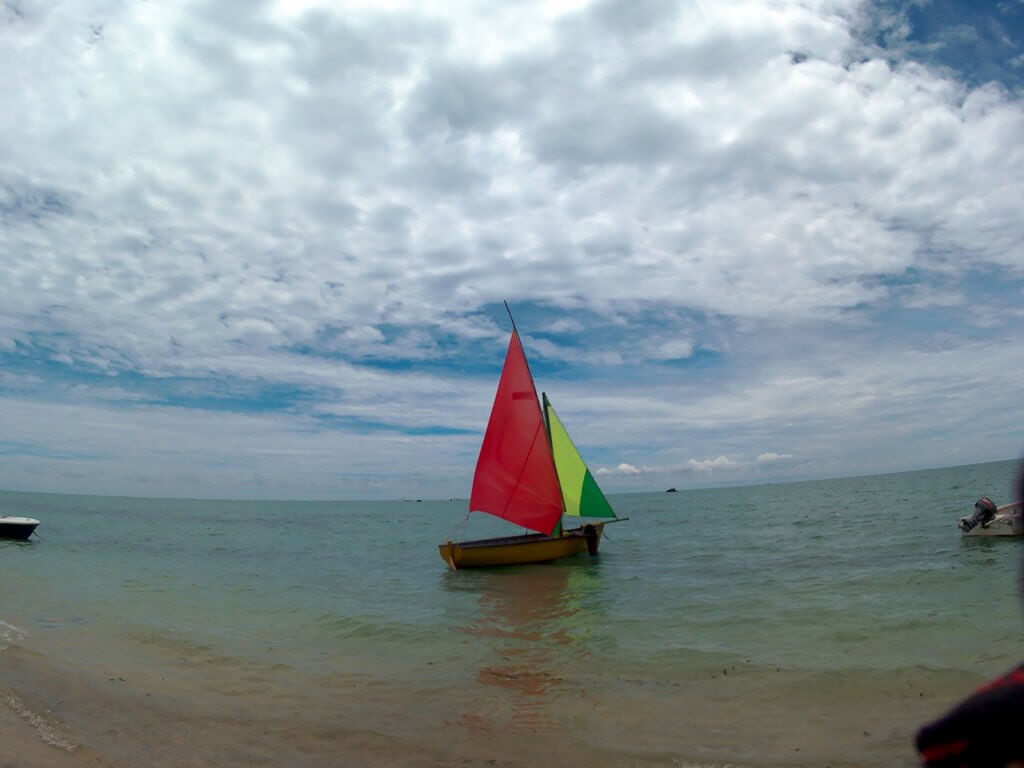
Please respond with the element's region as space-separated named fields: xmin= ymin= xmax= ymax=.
xmin=438 ymin=522 xmax=604 ymax=570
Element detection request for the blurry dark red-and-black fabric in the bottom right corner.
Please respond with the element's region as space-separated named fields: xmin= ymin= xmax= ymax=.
xmin=915 ymin=665 xmax=1024 ymax=768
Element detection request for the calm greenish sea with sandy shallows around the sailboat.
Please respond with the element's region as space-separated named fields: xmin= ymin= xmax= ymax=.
xmin=0 ymin=461 xmax=1024 ymax=768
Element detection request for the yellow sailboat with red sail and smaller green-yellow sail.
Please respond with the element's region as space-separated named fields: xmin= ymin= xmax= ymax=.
xmin=438 ymin=313 xmax=628 ymax=569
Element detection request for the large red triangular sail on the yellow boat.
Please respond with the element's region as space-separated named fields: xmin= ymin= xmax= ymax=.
xmin=469 ymin=331 xmax=562 ymax=535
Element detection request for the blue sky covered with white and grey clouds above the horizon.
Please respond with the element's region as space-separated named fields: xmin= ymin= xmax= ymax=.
xmin=0 ymin=0 xmax=1024 ymax=499
